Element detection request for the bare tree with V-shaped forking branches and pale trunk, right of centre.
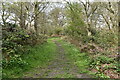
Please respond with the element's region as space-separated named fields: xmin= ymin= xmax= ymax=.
xmin=80 ymin=0 xmax=98 ymax=35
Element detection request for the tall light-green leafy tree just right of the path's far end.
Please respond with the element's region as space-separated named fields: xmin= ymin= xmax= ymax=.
xmin=65 ymin=3 xmax=89 ymax=43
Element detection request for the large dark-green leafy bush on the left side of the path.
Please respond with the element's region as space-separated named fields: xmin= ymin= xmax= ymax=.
xmin=2 ymin=24 xmax=47 ymax=69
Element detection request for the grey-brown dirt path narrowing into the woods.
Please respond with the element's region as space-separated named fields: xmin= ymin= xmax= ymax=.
xmin=25 ymin=41 xmax=89 ymax=78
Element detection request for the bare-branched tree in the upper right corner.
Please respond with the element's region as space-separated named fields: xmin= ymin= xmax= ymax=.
xmin=100 ymin=2 xmax=118 ymax=32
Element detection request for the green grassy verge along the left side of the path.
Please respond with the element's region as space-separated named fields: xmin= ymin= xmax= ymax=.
xmin=3 ymin=39 xmax=56 ymax=78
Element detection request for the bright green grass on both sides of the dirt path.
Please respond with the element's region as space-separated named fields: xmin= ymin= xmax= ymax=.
xmin=3 ymin=37 xmax=102 ymax=78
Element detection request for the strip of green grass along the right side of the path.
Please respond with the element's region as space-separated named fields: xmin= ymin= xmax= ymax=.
xmin=59 ymin=40 xmax=89 ymax=73
